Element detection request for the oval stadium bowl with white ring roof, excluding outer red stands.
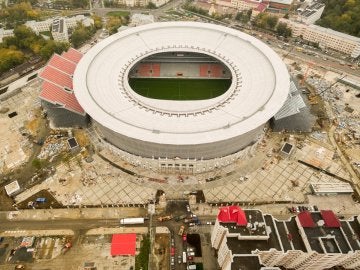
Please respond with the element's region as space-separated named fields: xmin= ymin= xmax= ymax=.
xmin=73 ymin=22 xmax=290 ymax=163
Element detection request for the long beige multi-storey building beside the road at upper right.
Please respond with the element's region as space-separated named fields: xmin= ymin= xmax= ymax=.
xmin=280 ymin=19 xmax=360 ymax=58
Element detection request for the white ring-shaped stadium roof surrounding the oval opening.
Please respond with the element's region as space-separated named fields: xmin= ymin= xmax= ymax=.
xmin=74 ymin=22 xmax=290 ymax=145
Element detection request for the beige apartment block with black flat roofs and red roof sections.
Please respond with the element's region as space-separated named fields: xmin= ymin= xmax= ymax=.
xmin=211 ymin=206 xmax=360 ymax=270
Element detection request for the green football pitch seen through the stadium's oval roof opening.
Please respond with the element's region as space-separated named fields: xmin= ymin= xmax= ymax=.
xmin=129 ymin=78 xmax=231 ymax=100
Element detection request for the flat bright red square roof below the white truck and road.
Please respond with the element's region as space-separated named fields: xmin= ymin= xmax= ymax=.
xmin=111 ymin=233 xmax=136 ymax=256
